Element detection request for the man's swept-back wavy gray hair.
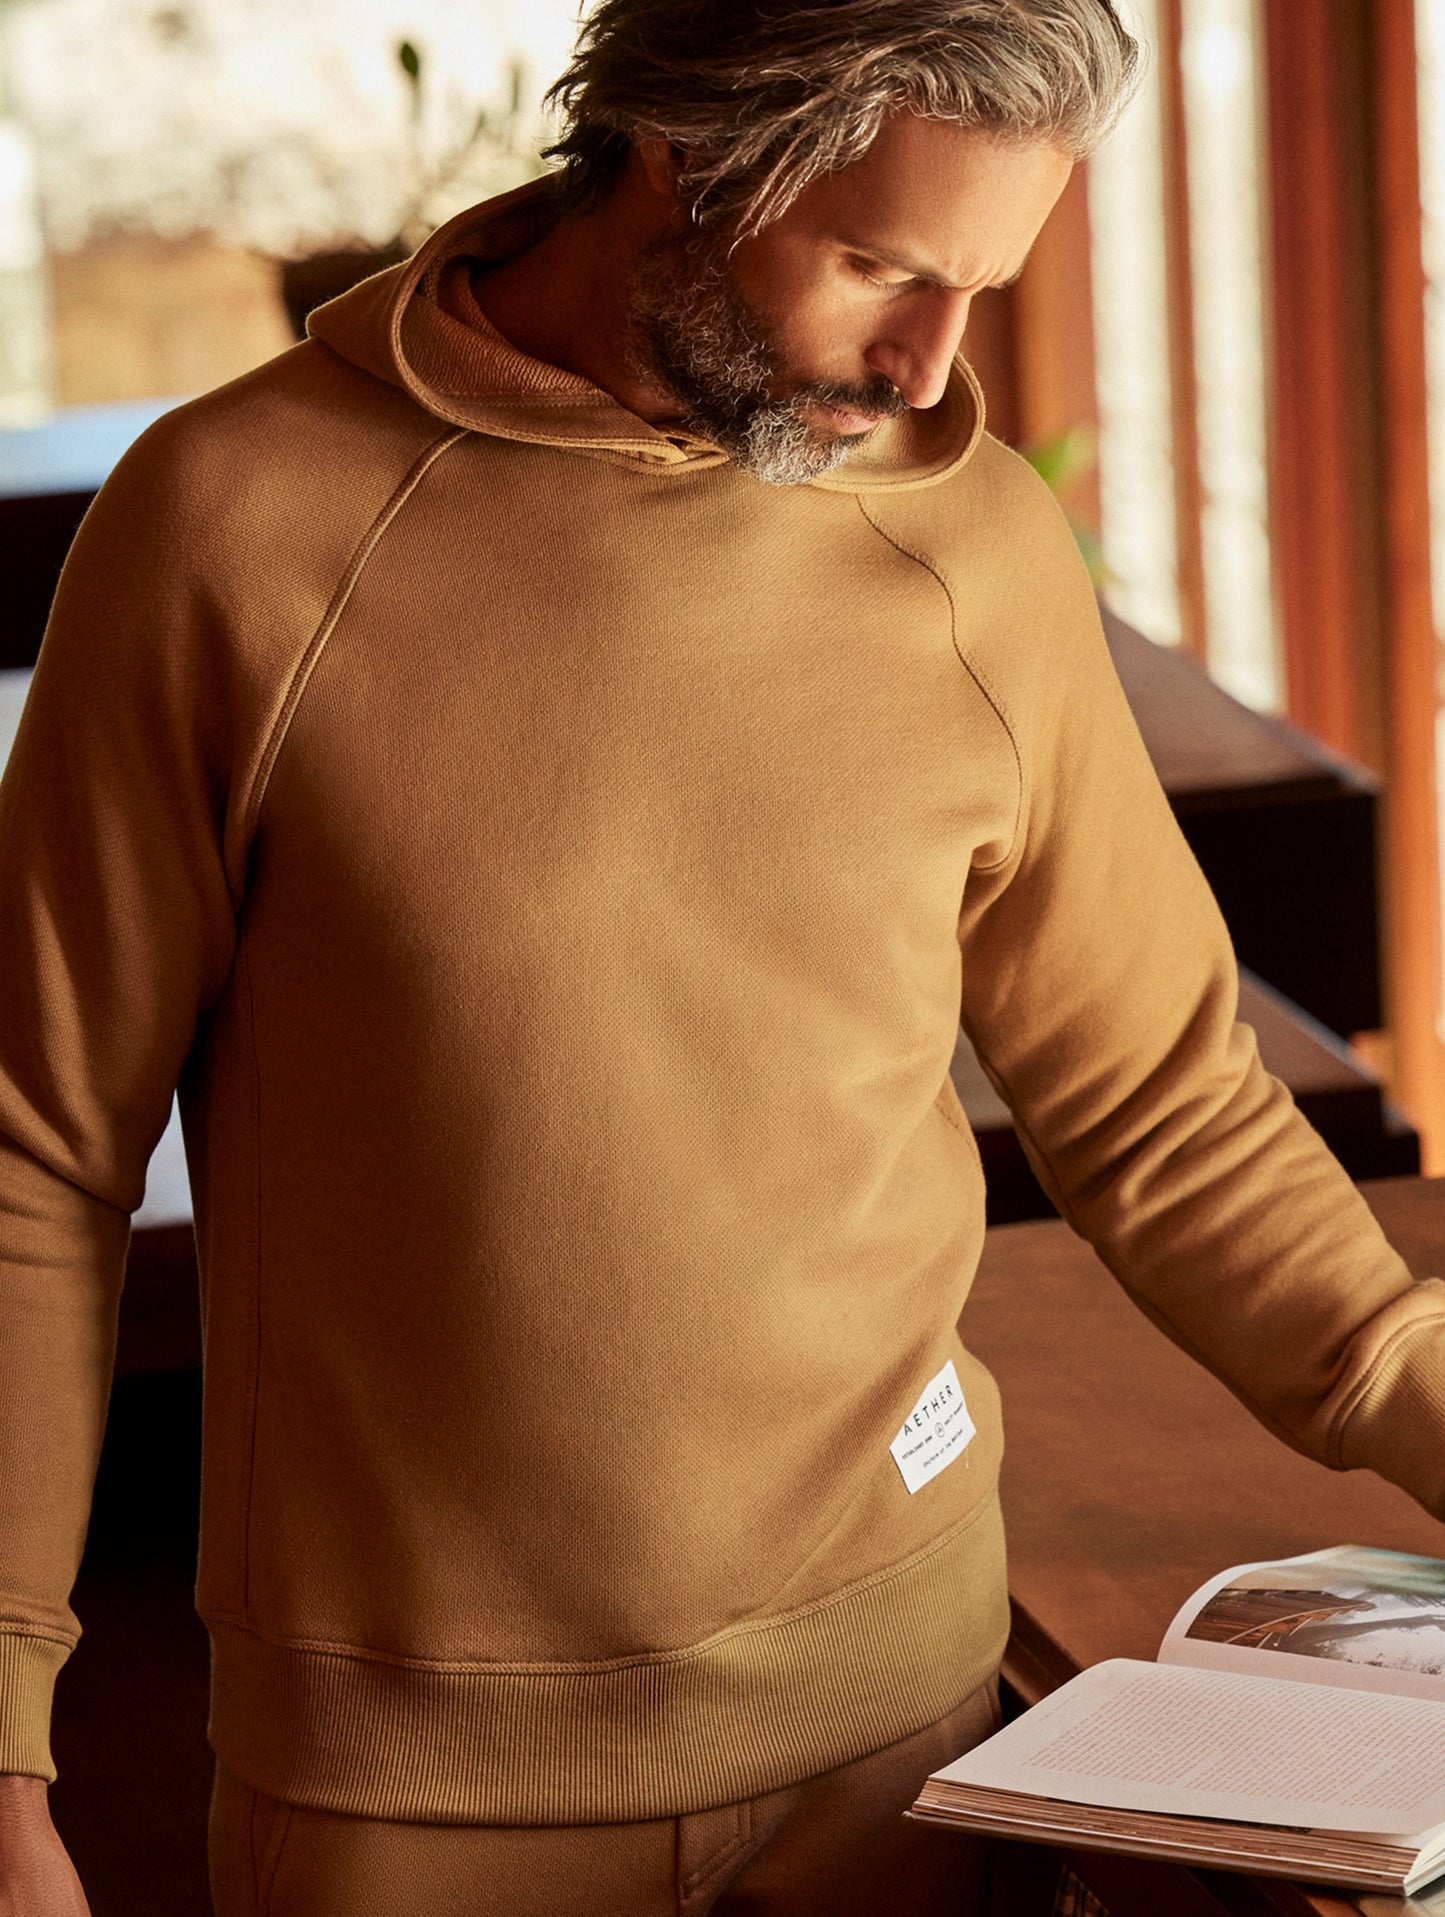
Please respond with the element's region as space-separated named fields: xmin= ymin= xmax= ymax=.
xmin=546 ymin=0 xmax=1140 ymax=236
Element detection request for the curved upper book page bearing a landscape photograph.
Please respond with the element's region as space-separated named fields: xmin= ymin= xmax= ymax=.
xmin=1159 ymin=1545 xmax=1445 ymax=1700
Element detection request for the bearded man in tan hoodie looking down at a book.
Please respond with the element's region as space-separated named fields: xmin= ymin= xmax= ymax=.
xmin=0 ymin=0 xmax=1445 ymax=1917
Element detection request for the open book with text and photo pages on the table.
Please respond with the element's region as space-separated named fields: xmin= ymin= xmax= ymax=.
xmin=912 ymin=1545 xmax=1445 ymax=1892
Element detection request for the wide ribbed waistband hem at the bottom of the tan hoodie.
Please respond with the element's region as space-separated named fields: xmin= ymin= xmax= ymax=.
xmin=211 ymin=1499 xmax=1008 ymax=1825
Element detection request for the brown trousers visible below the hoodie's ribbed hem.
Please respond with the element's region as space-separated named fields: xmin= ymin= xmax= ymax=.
xmin=211 ymin=1687 xmax=998 ymax=1917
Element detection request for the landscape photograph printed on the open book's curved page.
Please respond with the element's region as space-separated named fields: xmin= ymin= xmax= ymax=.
xmin=1171 ymin=1545 xmax=1445 ymax=1677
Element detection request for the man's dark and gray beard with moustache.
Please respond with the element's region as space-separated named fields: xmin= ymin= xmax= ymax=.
xmin=631 ymin=234 xmax=908 ymax=485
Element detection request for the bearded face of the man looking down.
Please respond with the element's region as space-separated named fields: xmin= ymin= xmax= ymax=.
xmin=632 ymin=113 xmax=1071 ymax=485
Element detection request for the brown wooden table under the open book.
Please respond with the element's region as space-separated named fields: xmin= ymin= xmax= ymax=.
xmin=962 ymin=1179 xmax=1445 ymax=1917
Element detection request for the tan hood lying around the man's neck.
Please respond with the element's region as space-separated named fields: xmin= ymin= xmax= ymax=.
xmin=307 ymin=180 xmax=983 ymax=493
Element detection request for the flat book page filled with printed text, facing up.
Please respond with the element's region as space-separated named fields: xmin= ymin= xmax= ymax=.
xmin=935 ymin=1658 xmax=1445 ymax=1848
